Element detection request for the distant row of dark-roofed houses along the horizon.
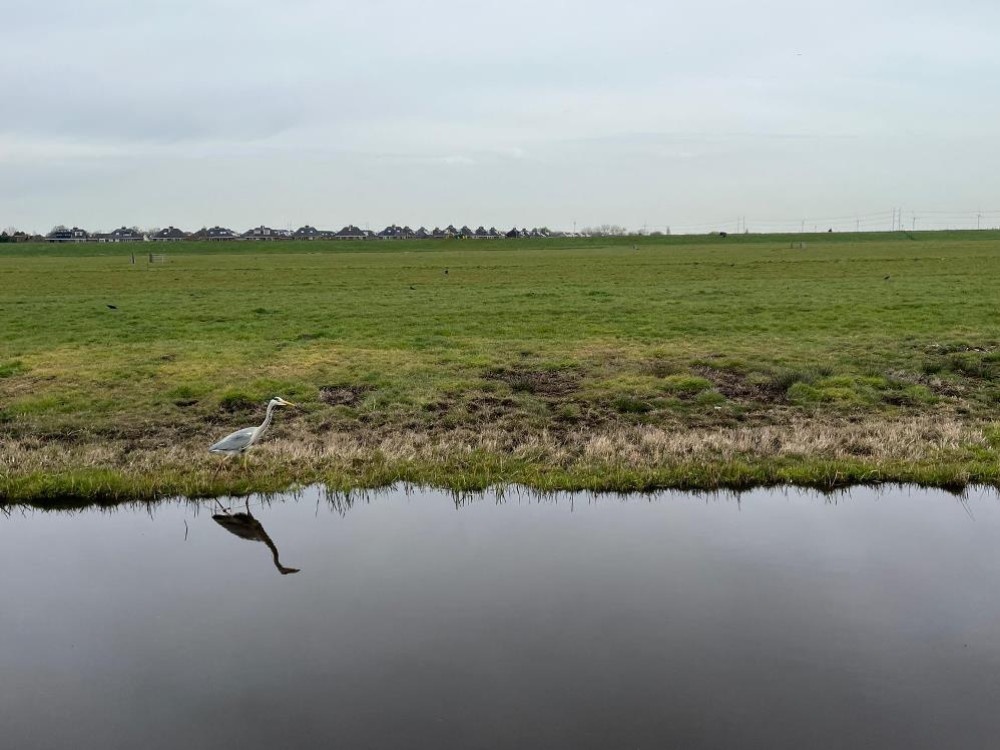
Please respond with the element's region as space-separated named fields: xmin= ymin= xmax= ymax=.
xmin=39 ymin=224 xmax=552 ymax=243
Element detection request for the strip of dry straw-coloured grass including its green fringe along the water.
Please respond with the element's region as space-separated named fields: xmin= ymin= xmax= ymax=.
xmin=0 ymin=416 xmax=1000 ymax=508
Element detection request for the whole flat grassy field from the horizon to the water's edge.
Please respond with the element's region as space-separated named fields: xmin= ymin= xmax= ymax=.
xmin=0 ymin=232 xmax=1000 ymax=502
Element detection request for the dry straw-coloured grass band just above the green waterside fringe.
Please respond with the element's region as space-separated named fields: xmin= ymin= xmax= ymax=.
xmin=0 ymin=416 xmax=989 ymax=477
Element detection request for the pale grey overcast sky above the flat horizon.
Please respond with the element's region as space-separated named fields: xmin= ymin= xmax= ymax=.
xmin=0 ymin=0 xmax=1000 ymax=231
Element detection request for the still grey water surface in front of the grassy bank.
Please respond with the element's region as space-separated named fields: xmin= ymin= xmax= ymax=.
xmin=0 ymin=490 xmax=1000 ymax=750
